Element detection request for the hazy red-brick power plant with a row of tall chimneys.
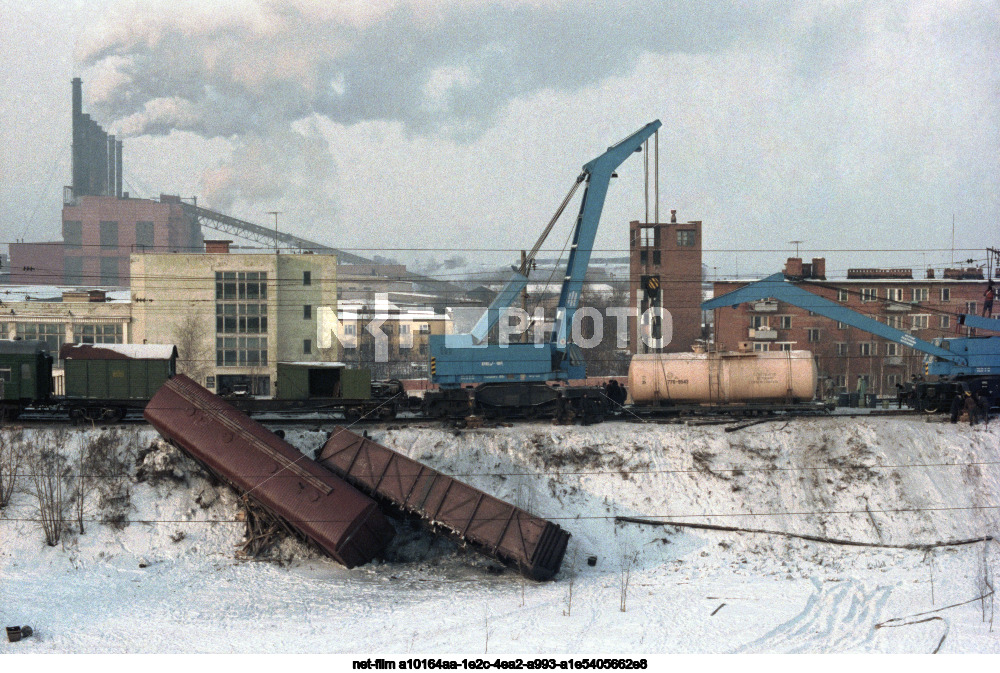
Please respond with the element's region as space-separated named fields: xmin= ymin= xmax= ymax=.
xmin=9 ymin=78 xmax=203 ymax=287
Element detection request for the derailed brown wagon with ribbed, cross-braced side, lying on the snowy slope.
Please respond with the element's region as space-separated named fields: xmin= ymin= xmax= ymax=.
xmin=317 ymin=427 xmax=569 ymax=580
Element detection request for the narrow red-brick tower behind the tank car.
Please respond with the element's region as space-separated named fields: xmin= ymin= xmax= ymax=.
xmin=629 ymin=210 xmax=702 ymax=353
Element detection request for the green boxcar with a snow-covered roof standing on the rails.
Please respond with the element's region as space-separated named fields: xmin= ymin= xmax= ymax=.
xmin=59 ymin=344 xmax=177 ymax=421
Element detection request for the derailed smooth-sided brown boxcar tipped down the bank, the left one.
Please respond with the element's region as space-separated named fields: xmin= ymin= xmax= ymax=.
xmin=143 ymin=375 xmax=394 ymax=568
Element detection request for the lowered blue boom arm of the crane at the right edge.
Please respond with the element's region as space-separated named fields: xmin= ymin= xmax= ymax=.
xmin=701 ymin=273 xmax=968 ymax=365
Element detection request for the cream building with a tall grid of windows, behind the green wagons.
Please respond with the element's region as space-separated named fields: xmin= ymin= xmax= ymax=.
xmin=130 ymin=241 xmax=341 ymax=396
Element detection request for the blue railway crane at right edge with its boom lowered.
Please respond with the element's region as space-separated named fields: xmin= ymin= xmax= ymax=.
xmin=701 ymin=273 xmax=1000 ymax=411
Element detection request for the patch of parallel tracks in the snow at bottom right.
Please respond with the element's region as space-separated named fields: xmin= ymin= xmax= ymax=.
xmin=735 ymin=579 xmax=892 ymax=654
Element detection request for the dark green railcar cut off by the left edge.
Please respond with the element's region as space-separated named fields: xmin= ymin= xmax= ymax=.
xmin=0 ymin=339 xmax=53 ymax=420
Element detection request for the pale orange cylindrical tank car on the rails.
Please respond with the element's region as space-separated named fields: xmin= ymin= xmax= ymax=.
xmin=628 ymin=351 xmax=819 ymax=406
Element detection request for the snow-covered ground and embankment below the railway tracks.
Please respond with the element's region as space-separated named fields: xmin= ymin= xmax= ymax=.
xmin=0 ymin=418 xmax=1000 ymax=656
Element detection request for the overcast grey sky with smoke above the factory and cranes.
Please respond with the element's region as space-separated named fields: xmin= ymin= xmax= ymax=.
xmin=0 ymin=0 xmax=1000 ymax=275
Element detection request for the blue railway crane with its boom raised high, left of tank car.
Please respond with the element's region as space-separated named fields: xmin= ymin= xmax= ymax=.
xmin=425 ymin=120 xmax=661 ymax=415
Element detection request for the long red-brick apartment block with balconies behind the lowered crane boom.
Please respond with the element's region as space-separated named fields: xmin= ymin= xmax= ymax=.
xmin=713 ymin=258 xmax=986 ymax=395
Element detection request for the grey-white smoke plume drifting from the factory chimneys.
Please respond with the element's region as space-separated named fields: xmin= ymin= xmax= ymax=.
xmin=80 ymin=0 xmax=767 ymax=214
